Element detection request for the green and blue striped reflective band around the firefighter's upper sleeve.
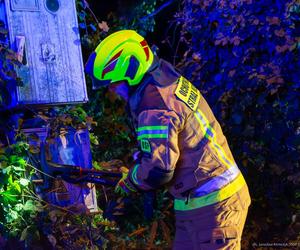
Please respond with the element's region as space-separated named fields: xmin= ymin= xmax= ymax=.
xmin=137 ymin=126 xmax=168 ymax=140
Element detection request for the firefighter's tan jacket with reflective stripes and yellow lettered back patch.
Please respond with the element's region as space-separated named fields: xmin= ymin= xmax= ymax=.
xmin=128 ymin=57 xmax=250 ymax=216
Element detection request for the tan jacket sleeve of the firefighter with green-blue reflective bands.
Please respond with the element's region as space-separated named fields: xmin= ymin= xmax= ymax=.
xmin=128 ymin=110 xmax=182 ymax=191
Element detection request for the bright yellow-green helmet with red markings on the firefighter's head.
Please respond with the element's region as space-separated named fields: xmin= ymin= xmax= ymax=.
xmin=85 ymin=30 xmax=154 ymax=88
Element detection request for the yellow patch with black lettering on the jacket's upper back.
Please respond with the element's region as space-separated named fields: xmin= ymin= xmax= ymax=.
xmin=175 ymin=76 xmax=200 ymax=111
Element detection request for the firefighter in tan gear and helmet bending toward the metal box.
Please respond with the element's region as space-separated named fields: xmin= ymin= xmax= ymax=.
xmin=86 ymin=30 xmax=251 ymax=250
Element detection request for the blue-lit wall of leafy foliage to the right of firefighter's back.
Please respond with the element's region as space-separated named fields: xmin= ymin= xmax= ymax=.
xmin=177 ymin=0 xmax=300 ymax=248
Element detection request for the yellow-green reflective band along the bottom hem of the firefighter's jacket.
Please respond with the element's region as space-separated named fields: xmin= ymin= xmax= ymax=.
xmin=174 ymin=174 xmax=246 ymax=211
